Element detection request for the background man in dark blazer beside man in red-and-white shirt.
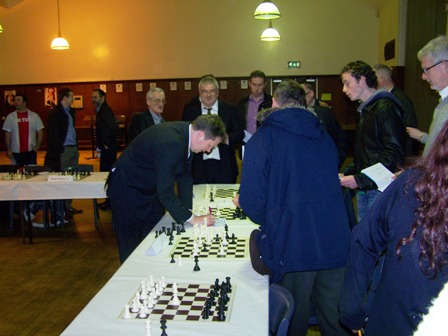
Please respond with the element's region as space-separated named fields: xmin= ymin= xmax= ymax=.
xmin=44 ymin=88 xmax=82 ymax=214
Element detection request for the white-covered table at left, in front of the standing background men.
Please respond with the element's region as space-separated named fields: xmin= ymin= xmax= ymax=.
xmin=0 ymin=172 xmax=108 ymax=243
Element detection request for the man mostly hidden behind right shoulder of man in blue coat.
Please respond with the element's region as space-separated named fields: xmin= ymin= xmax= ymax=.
xmin=302 ymin=83 xmax=347 ymax=168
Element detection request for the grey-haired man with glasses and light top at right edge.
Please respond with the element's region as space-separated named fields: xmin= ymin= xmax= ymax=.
xmin=406 ymin=36 xmax=448 ymax=156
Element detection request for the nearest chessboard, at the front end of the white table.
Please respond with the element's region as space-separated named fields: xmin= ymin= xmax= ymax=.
xmin=118 ymin=284 xmax=235 ymax=323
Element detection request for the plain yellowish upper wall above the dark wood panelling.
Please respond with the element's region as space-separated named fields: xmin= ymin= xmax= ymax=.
xmin=0 ymin=0 xmax=378 ymax=84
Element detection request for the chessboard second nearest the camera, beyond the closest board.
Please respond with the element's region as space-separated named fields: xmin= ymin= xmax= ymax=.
xmin=169 ymin=236 xmax=249 ymax=259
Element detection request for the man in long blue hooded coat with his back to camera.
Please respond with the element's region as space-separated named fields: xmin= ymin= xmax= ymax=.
xmin=239 ymin=80 xmax=350 ymax=336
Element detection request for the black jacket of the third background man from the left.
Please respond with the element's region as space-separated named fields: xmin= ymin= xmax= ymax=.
xmin=96 ymin=102 xmax=118 ymax=150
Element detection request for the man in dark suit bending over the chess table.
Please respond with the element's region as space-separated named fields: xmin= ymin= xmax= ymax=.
xmin=107 ymin=115 xmax=226 ymax=263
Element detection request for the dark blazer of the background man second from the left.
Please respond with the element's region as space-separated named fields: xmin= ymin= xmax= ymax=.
xmin=44 ymin=103 xmax=76 ymax=171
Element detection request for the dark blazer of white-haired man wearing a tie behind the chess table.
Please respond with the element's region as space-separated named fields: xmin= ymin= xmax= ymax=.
xmin=182 ymin=101 xmax=244 ymax=184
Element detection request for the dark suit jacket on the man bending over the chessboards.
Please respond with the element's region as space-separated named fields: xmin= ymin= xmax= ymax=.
xmin=107 ymin=121 xmax=193 ymax=223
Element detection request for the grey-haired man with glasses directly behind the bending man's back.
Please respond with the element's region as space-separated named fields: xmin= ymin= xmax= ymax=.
xmin=128 ymin=87 xmax=166 ymax=143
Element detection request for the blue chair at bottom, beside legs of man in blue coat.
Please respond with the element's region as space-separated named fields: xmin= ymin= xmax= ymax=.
xmin=269 ymin=284 xmax=296 ymax=336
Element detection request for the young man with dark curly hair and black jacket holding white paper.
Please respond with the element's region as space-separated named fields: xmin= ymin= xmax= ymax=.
xmin=341 ymin=61 xmax=406 ymax=221
